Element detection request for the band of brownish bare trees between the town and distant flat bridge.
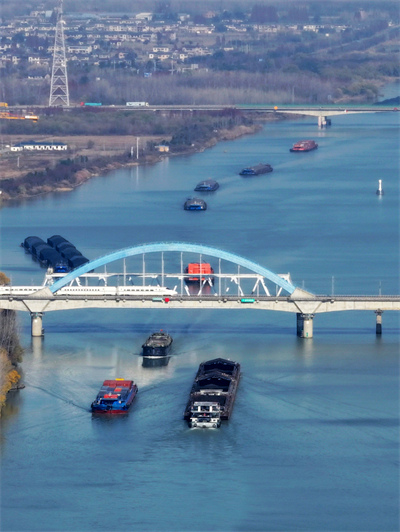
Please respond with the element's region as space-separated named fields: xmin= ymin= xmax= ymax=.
xmin=1 ymin=67 xmax=382 ymax=107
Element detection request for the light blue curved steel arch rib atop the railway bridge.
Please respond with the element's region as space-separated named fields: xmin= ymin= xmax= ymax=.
xmin=49 ymin=242 xmax=296 ymax=294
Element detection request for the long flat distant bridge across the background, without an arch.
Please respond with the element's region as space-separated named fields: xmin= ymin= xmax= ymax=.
xmin=8 ymin=104 xmax=399 ymax=128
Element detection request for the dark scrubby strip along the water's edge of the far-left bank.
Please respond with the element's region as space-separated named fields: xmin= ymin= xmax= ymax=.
xmin=0 ymin=117 xmax=268 ymax=203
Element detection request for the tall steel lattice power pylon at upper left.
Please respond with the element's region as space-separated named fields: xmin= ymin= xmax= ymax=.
xmin=49 ymin=0 xmax=69 ymax=107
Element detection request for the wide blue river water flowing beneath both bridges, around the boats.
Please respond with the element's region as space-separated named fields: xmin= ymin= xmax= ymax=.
xmin=0 ymin=97 xmax=400 ymax=532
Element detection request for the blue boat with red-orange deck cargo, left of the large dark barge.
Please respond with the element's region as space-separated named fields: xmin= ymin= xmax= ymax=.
xmin=91 ymin=379 xmax=138 ymax=414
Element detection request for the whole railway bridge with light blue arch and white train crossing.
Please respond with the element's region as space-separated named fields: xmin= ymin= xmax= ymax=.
xmin=0 ymin=242 xmax=400 ymax=338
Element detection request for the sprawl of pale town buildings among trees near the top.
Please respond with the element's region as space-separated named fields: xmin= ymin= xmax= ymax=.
xmin=0 ymin=6 xmax=382 ymax=79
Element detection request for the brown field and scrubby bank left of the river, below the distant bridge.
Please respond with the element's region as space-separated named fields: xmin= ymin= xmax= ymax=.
xmin=0 ymin=115 xmax=282 ymax=202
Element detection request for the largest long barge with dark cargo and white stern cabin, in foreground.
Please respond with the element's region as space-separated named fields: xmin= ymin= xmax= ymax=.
xmin=183 ymin=358 xmax=240 ymax=428
